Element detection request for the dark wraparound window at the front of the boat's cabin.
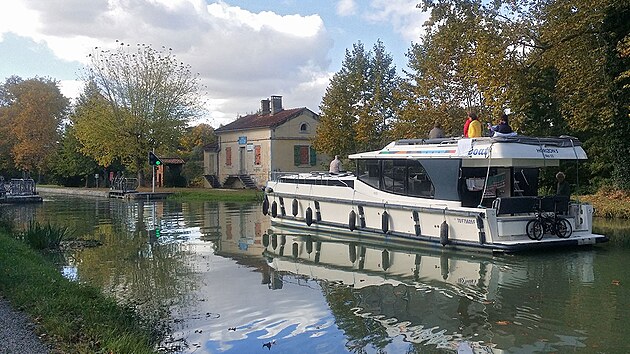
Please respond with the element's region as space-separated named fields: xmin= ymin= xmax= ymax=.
xmin=357 ymin=159 xmax=435 ymax=198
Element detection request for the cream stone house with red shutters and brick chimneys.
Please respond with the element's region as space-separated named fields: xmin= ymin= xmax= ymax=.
xmin=204 ymin=96 xmax=327 ymax=188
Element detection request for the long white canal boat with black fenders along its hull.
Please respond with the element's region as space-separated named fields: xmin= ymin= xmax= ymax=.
xmin=263 ymin=136 xmax=608 ymax=252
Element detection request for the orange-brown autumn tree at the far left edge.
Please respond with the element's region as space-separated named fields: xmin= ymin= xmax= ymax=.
xmin=0 ymin=77 xmax=69 ymax=178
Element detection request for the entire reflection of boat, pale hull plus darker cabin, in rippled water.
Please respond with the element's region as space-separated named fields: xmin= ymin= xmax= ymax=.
xmin=263 ymin=229 xmax=526 ymax=353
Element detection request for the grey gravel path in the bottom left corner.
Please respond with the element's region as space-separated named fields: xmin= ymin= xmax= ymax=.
xmin=0 ymin=297 xmax=50 ymax=354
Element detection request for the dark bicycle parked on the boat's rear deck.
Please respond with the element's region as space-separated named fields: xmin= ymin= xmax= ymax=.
xmin=525 ymin=197 xmax=573 ymax=241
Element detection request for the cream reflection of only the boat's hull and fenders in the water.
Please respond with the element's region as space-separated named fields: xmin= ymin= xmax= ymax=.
xmin=263 ymin=233 xmax=496 ymax=294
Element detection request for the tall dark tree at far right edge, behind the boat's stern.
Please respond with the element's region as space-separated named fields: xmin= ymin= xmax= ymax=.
xmin=529 ymin=0 xmax=630 ymax=189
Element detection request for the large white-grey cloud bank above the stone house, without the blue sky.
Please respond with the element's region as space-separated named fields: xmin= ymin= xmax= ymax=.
xmin=0 ymin=0 xmax=332 ymax=126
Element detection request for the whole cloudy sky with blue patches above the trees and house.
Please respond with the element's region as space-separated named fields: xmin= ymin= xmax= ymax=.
xmin=0 ymin=0 xmax=427 ymax=128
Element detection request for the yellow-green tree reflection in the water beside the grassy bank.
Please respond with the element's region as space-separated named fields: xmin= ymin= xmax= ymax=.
xmin=71 ymin=225 xmax=196 ymax=326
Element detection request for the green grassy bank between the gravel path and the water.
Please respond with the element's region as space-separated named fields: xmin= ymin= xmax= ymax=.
xmin=0 ymin=229 xmax=159 ymax=353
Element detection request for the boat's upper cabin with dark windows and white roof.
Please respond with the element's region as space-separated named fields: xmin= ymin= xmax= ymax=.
xmin=350 ymin=137 xmax=586 ymax=210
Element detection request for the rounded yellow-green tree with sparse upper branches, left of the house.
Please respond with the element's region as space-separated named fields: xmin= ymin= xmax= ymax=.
xmin=75 ymin=43 xmax=202 ymax=183
